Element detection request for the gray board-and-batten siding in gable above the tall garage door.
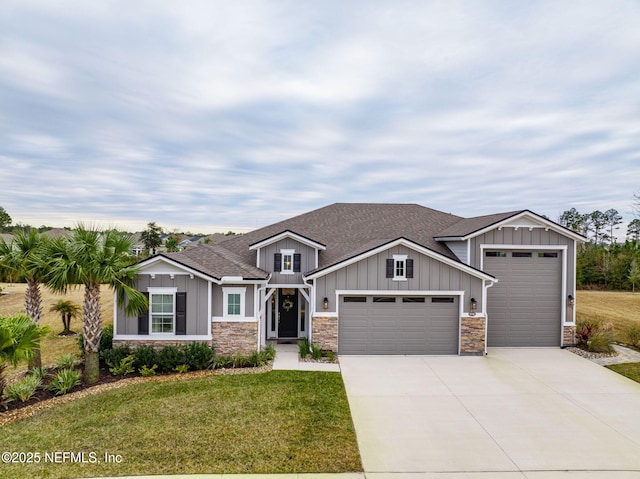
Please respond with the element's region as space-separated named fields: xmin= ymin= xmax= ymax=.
xmin=469 ymin=227 xmax=576 ymax=292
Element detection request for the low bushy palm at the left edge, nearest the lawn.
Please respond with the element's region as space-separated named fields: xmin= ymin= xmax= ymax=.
xmin=0 ymin=314 xmax=49 ymax=404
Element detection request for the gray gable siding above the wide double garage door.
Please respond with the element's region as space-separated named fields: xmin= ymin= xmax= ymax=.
xmin=315 ymin=246 xmax=482 ymax=312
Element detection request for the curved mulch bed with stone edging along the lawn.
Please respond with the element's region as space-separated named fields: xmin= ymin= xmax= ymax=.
xmin=0 ymin=361 xmax=273 ymax=426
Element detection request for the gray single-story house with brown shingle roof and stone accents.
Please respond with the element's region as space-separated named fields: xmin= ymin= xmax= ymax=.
xmin=114 ymin=204 xmax=584 ymax=354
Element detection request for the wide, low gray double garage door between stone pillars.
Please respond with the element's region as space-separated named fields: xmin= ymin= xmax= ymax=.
xmin=338 ymin=296 xmax=459 ymax=354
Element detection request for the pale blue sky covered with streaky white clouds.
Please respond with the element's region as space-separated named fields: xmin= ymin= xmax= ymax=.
xmin=0 ymin=0 xmax=640 ymax=234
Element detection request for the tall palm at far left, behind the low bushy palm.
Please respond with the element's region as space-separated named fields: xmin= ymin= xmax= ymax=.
xmin=0 ymin=229 xmax=48 ymax=367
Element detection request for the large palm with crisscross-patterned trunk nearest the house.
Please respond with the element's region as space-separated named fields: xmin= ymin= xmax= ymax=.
xmin=47 ymin=225 xmax=147 ymax=384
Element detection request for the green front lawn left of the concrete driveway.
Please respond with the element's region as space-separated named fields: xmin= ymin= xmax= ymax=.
xmin=0 ymin=371 xmax=362 ymax=479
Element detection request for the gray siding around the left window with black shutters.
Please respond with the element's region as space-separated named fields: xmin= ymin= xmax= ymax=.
xmin=116 ymin=274 xmax=210 ymax=336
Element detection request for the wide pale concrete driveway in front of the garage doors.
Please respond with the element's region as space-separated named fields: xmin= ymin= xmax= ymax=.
xmin=340 ymin=349 xmax=640 ymax=479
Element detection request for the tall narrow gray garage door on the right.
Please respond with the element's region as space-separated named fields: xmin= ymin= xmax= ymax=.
xmin=483 ymin=250 xmax=562 ymax=346
